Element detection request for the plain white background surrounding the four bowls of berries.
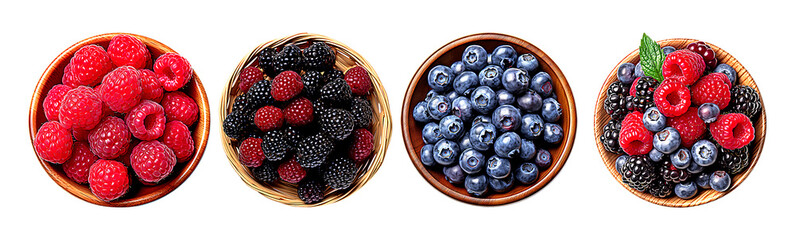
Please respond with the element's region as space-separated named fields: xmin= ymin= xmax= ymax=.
xmin=0 ymin=1 xmax=795 ymax=239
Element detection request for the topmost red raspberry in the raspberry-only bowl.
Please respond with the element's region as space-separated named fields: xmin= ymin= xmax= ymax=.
xmin=108 ymin=34 xmax=151 ymax=69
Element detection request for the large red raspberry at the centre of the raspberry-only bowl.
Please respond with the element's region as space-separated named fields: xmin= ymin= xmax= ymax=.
xmin=99 ymin=66 xmax=143 ymax=113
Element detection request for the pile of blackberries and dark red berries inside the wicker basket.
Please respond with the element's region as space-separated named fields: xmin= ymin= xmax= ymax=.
xmin=223 ymin=42 xmax=375 ymax=204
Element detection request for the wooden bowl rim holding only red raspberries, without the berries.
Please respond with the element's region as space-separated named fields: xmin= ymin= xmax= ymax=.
xmin=29 ymin=33 xmax=210 ymax=207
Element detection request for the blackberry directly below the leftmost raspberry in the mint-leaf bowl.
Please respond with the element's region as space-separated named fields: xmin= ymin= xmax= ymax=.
xmin=619 ymin=155 xmax=657 ymax=192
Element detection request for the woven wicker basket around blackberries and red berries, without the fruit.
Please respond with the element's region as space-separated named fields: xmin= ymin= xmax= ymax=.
xmin=219 ymin=33 xmax=392 ymax=207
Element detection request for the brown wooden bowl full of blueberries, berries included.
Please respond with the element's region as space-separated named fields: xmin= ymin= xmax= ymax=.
xmin=402 ymin=33 xmax=577 ymax=205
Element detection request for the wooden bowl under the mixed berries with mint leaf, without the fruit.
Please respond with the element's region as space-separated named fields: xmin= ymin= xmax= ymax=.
xmin=594 ymin=38 xmax=767 ymax=207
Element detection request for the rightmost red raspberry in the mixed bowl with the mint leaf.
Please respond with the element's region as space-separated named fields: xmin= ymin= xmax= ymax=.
xmin=709 ymin=113 xmax=756 ymax=150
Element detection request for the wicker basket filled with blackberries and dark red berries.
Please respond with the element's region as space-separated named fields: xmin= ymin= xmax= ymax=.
xmin=221 ymin=33 xmax=392 ymax=207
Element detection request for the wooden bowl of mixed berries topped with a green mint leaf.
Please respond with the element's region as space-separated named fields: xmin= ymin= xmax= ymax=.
xmin=594 ymin=34 xmax=766 ymax=207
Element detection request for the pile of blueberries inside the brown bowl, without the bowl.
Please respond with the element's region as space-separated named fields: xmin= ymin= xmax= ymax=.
xmin=413 ymin=45 xmax=563 ymax=197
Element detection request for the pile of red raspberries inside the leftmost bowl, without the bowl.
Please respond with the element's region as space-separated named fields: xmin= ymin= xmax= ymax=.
xmin=33 ymin=34 xmax=199 ymax=201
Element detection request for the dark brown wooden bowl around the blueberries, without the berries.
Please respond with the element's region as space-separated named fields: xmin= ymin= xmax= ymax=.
xmin=401 ymin=33 xmax=577 ymax=205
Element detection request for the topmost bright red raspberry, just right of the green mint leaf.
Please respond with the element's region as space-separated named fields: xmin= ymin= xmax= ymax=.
xmin=663 ymin=49 xmax=706 ymax=85
